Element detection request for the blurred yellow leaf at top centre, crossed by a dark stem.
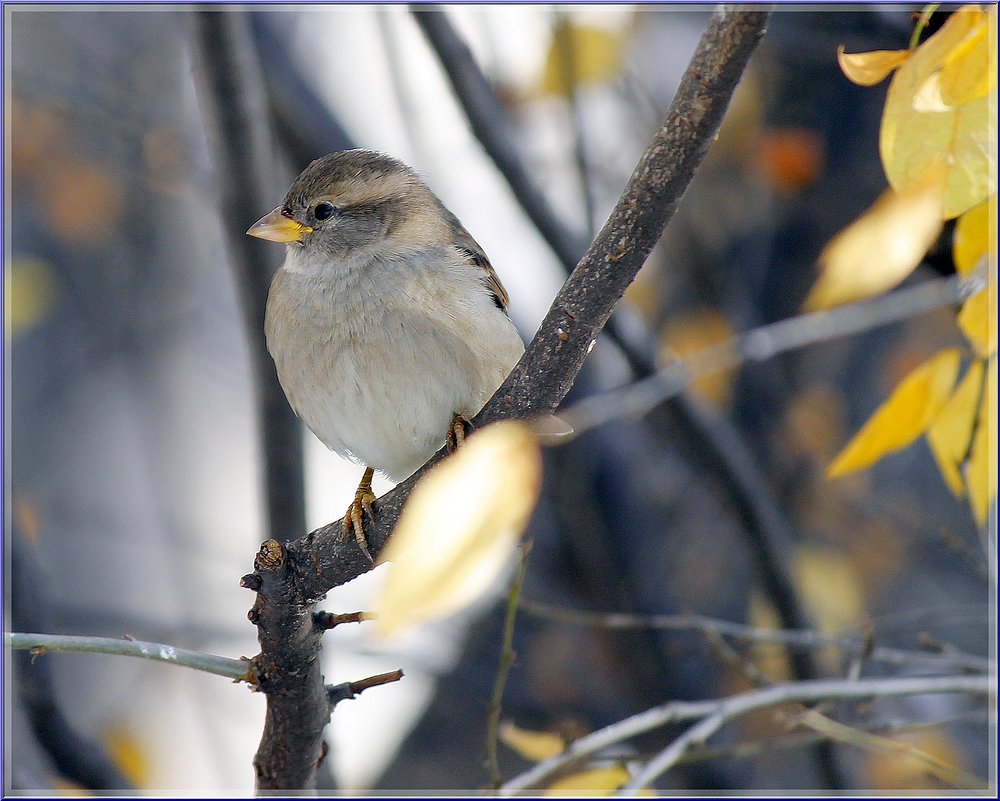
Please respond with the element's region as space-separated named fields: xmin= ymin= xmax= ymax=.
xmin=541 ymin=17 xmax=624 ymax=96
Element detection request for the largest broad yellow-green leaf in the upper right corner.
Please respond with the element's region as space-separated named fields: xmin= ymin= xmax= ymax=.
xmin=879 ymin=5 xmax=996 ymax=219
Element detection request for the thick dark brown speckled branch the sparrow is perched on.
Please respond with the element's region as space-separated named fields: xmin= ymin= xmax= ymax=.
xmin=244 ymin=9 xmax=768 ymax=789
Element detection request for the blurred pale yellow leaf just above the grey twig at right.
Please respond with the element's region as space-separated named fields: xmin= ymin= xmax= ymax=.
xmin=805 ymin=180 xmax=942 ymax=309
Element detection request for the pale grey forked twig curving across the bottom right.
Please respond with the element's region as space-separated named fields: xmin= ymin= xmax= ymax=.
xmin=499 ymin=676 xmax=995 ymax=796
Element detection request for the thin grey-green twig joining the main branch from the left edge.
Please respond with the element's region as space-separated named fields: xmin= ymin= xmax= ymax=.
xmin=3 ymin=632 xmax=253 ymax=681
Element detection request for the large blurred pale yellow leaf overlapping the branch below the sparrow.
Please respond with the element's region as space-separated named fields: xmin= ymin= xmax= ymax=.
xmin=375 ymin=421 xmax=542 ymax=635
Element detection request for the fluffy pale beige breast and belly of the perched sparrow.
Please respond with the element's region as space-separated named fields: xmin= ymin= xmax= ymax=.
xmin=265 ymin=261 xmax=523 ymax=479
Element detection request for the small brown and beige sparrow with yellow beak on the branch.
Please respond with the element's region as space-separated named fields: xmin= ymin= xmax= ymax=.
xmin=247 ymin=149 xmax=524 ymax=561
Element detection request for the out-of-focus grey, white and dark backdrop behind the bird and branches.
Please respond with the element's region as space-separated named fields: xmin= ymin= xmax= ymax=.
xmin=4 ymin=6 xmax=994 ymax=793
